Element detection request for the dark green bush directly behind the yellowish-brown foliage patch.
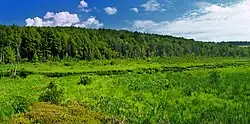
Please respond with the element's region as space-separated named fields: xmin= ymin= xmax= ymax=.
xmin=39 ymin=82 xmax=64 ymax=104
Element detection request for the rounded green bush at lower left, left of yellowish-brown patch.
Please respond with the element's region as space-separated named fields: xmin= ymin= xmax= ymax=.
xmin=11 ymin=96 xmax=29 ymax=113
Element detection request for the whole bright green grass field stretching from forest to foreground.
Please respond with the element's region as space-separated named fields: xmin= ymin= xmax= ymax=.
xmin=0 ymin=58 xmax=250 ymax=124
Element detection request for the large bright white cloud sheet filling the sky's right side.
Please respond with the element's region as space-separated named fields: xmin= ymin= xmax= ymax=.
xmin=132 ymin=0 xmax=250 ymax=41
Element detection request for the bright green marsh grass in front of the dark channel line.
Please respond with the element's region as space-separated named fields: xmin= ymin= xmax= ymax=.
xmin=0 ymin=66 xmax=250 ymax=123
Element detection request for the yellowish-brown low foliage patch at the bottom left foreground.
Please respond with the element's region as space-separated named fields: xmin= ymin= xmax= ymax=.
xmin=11 ymin=103 xmax=123 ymax=124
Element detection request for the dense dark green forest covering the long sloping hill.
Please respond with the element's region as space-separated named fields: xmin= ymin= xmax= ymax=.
xmin=0 ymin=25 xmax=250 ymax=63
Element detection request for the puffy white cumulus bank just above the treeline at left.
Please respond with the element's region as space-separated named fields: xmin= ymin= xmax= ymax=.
xmin=25 ymin=12 xmax=104 ymax=28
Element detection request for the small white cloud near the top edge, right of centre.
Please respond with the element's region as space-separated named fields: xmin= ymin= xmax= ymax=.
xmin=141 ymin=0 xmax=163 ymax=11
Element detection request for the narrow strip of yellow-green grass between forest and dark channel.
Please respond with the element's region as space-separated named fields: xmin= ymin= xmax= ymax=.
xmin=0 ymin=57 xmax=250 ymax=73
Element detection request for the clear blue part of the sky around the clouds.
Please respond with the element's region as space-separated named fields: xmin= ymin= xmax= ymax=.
xmin=0 ymin=0 xmax=195 ymax=28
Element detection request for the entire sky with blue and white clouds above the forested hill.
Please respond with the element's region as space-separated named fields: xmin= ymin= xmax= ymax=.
xmin=0 ymin=0 xmax=250 ymax=42
